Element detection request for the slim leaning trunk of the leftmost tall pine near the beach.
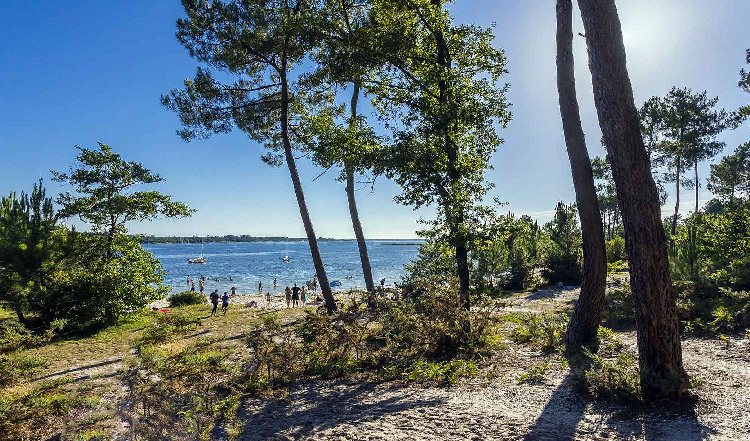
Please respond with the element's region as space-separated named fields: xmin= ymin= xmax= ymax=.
xmin=280 ymin=59 xmax=336 ymax=314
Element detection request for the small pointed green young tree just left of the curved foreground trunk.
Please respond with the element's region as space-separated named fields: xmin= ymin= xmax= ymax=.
xmin=544 ymin=202 xmax=583 ymax=285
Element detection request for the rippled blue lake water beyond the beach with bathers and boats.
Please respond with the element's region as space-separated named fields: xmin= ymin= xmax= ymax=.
xmin=143 ymin=240 xmax=418 ymax=293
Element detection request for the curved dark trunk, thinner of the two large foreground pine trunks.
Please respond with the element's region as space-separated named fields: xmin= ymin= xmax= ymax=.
xmin=557 ymin=0 xmax=607 ymax=351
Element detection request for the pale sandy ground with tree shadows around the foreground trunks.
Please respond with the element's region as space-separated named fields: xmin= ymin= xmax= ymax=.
xmin=232 ymin=289 xmax=750 ymax=441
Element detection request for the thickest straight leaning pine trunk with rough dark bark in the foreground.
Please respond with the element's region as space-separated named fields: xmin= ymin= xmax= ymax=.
xmin=578 ymin=0 xmax=688 ymax=398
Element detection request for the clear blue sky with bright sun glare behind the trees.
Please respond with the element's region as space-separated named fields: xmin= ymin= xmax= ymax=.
xmin=0 ymin=0 xmax=750 ymax=238
